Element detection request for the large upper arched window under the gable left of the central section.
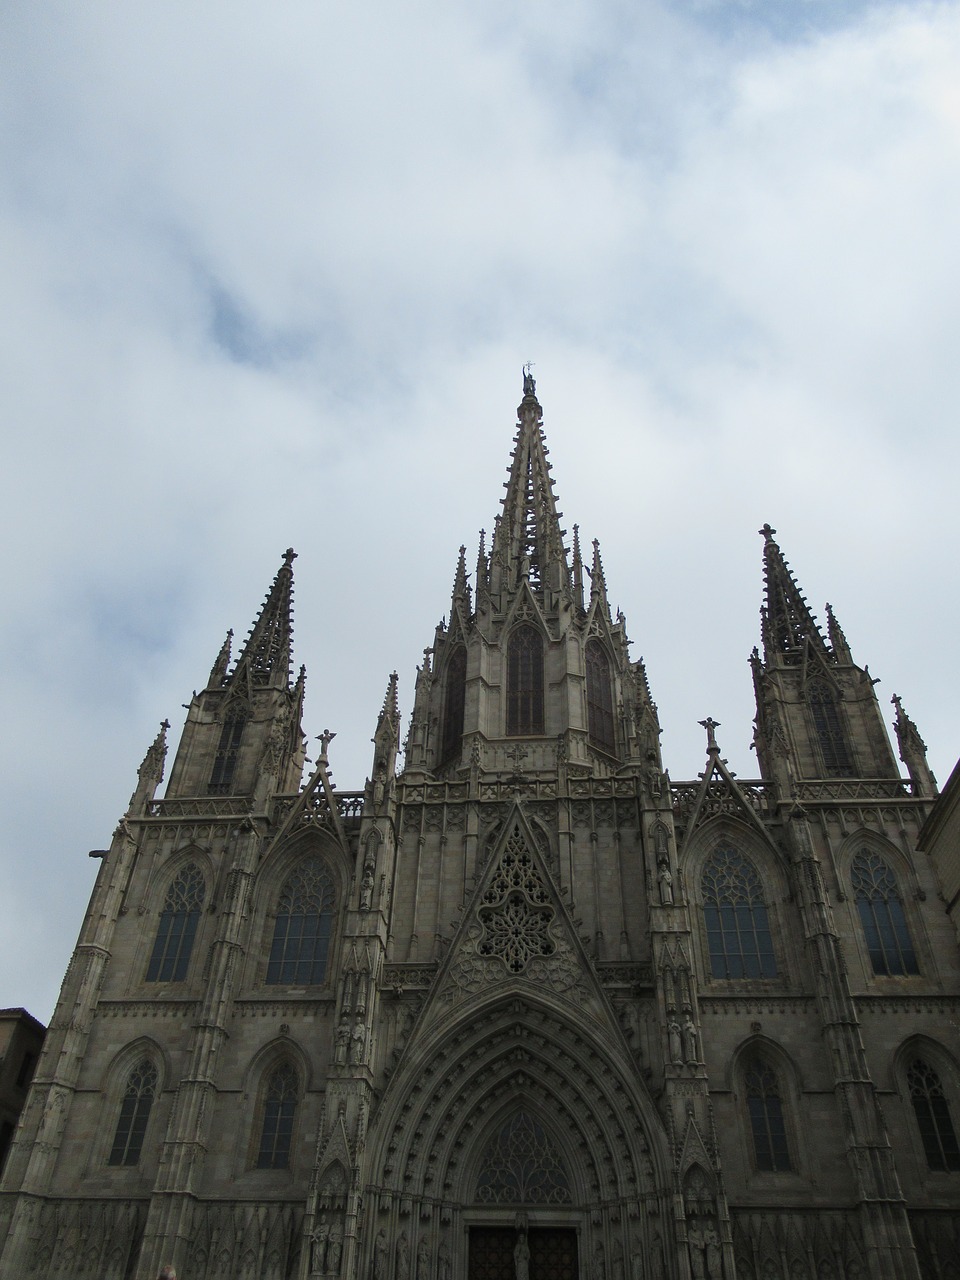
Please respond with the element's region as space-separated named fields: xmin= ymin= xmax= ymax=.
xmin=266 ymin=858 xmax=334 ymax=986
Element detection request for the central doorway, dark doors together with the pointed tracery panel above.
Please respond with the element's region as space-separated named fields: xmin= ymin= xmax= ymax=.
xmin=467 ymin=1105 xmax=580 ymax=1280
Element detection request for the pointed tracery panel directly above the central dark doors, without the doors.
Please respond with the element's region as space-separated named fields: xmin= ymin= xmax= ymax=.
xmin=476 ymin=1111 xmax=571 ymax=1204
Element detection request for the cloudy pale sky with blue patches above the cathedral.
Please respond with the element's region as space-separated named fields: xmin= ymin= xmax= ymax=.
xmin=0 ymin=0 xmax=960 ymax=1021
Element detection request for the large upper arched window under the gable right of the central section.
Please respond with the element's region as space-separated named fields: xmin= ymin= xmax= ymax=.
xmin=701 ymin=845 xmax=777 ymax=978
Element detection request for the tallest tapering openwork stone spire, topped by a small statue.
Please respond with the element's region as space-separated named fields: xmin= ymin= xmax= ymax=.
xmin=490 ymin=366 xmax=570 ymax=593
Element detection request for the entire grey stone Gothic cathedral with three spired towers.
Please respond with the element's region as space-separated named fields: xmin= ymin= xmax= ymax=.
xmin=0 ymin=375 xmax=960 ymax=1280
